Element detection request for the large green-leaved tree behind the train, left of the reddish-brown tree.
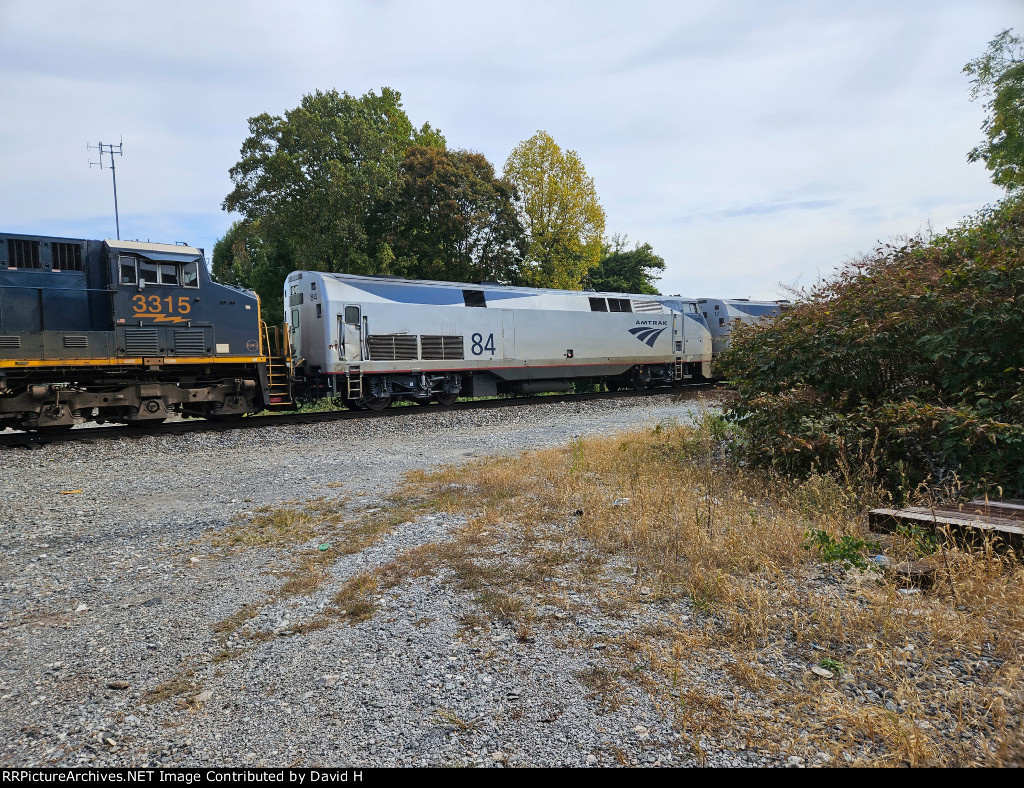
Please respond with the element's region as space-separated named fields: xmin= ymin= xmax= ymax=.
xmin=223 ymin=87 xmax=444 ymax=288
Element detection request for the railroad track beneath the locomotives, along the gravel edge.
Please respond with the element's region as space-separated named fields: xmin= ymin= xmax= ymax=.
xmin=0 ymin=383 xmax=717 ymax=448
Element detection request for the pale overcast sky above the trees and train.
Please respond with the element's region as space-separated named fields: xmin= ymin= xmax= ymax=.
xmin=0 ymin=0 xmax=1024 ymax=298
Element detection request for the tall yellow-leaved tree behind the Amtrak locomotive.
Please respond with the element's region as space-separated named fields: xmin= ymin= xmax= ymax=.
xmin=505 ymin=131 xmax=604 ymax=290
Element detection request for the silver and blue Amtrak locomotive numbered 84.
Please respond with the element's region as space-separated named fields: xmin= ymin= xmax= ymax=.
xmin=284 ymin=271 xmax=711 ymax=409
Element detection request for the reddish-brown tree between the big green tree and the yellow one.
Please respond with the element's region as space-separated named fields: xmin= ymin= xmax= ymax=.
xmin=388 ymin=145 xmax=527 ymax=283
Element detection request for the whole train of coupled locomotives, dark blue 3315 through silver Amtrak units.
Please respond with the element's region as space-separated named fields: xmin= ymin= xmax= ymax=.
xmin=0 ymin=233 xmax=782 ymax=431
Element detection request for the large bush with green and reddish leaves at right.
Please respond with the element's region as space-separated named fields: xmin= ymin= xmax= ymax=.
xmin=721 ymin=200 xmax=1024 ymax=496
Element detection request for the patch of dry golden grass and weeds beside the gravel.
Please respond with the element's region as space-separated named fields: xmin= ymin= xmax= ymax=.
xmin=375 ymin=413 xmax=1024 ymax=765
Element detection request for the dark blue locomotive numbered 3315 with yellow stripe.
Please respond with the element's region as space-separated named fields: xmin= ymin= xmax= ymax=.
xmin=0 ymin=233 xmax=290 ymax=430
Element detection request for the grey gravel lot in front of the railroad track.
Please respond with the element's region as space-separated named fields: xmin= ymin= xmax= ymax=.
xmin=0 ymin=388 xmax=729 ymax=767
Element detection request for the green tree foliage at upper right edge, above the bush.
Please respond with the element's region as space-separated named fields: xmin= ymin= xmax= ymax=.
xmin=964 ymin=28 xmax=1024 ymax=192
